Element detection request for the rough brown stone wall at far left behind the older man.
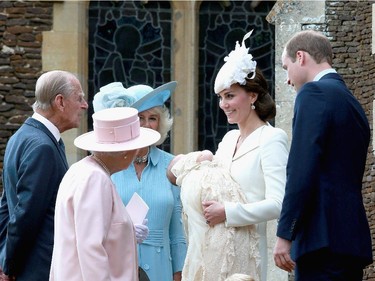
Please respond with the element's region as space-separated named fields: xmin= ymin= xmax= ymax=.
xmin=0 ymin=0 xmax=53 ymax=179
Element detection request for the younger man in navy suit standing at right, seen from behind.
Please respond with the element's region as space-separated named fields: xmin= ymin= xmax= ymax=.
xmin=274 ymin=30 xmax=372 ymax=281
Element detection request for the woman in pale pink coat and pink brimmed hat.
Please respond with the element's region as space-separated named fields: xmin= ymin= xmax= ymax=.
xmin=50 ymin=107 xmax=160 ymax=281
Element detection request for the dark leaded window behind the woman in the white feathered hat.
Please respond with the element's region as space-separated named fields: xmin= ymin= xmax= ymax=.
xmin=198 ymin=1 xmax=275 ymax=151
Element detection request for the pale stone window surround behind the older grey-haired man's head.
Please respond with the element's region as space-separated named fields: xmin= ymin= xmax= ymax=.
xmin=42 ymin=1 xmax=89 ymax=164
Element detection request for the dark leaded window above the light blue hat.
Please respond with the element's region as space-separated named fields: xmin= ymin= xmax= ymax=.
xmin=88 ymin=1 xmax=172 ymax=150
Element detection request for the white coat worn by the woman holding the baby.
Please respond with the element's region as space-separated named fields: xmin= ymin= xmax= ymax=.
xmin=216 ymin=125 xmax=288 ymax=281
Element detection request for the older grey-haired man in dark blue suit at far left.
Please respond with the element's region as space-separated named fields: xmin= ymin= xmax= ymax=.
xmin=0 ymin=70 xmax=88 ymax=281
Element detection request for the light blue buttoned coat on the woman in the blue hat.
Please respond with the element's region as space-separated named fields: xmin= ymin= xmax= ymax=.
xmin=112 ymin=146 xmax=187 ymax=281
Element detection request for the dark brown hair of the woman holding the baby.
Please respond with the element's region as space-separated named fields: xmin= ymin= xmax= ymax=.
xmin=240 ymin=68 xmax=276 ymax=121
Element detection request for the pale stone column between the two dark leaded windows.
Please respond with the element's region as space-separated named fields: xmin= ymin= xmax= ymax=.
xmin=171 ymin=0 xmax=200 ymax=154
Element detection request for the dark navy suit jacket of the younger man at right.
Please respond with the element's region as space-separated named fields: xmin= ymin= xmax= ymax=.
xmin=277 ymin=73 xmax=372 ymax=265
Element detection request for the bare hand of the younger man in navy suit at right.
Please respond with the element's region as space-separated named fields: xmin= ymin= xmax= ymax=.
xmin=273 ymin=237 xmax=296 ymax=272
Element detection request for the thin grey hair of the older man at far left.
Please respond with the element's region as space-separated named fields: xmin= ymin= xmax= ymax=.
xmin=33 ymin=70 xmax=77 ymax=111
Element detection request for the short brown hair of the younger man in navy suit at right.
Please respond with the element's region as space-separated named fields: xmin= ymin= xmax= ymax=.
xmin=285 ymin=30 xmax=333 ymax=65
